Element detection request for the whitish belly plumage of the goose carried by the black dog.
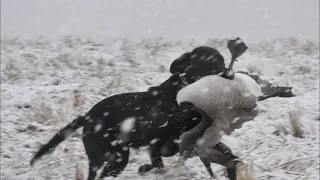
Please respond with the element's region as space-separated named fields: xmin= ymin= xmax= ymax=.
xmin=177 ymin=73 xmax=261 ymax=129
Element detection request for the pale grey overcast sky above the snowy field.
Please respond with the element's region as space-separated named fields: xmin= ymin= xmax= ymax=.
xmin=1 ymin=0 xmax=319 ymax=41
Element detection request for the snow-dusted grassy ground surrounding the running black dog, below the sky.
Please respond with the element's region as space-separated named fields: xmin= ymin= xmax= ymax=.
xmin=1 ymin=37 xmax=319 ymax=180
